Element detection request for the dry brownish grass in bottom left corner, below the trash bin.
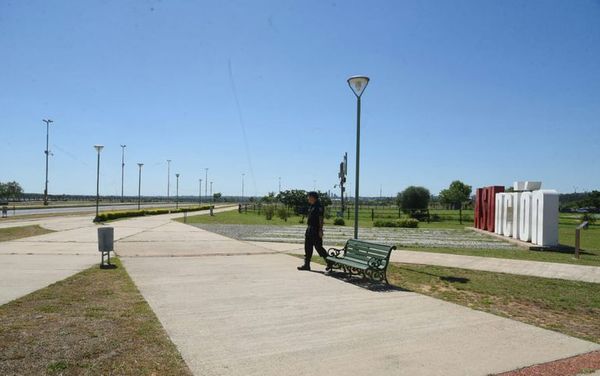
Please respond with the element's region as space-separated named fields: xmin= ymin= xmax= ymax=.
xmin=0 ymin=258 xmax=191 ymax=375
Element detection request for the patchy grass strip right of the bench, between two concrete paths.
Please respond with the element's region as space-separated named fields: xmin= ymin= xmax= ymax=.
xmin=313 ymin=257 xmax=600 ymax=343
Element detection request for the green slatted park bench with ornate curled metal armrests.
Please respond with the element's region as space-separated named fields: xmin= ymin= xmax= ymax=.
xmin=327 ymin=239 xmax=396 ymax=283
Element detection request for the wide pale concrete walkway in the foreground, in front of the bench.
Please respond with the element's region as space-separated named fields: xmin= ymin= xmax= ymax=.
xmin=117 ymin=223 xmax=600 ymax=376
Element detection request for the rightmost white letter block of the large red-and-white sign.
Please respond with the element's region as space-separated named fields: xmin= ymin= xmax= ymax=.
xmin=531 ymin=190 xmax=558 ymax=247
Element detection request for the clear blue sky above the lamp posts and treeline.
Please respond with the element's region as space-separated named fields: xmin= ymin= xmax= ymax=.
xmin=0 ymin=0 xmax=600 ymax=195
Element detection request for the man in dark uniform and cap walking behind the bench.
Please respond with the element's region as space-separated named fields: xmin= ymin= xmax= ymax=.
xmin=298 ymin=192 xmax=329 ymax=270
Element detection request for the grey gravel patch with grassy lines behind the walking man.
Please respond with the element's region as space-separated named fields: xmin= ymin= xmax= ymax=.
xmin=194 ymin=224 xmax=514 ymax=249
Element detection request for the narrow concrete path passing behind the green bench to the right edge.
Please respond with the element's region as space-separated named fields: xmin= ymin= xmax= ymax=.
xmin=251 ymin=242 xmax=600 ymax=283
